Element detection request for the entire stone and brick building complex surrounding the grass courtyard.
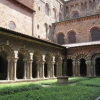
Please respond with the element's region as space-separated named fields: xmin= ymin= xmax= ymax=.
xmin=0 ymin=0 xmax=100 ymax=81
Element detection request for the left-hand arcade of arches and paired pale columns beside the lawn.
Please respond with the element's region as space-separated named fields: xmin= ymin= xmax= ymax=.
xmin=0 ymin=45 xmax=62 ymax=80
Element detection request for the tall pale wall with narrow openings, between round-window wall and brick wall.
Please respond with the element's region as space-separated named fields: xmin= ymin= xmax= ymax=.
xmin=34 ymin=0 xmax=64 ymax=40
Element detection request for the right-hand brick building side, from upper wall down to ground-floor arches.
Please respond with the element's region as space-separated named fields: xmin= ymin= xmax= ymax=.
xmin=54 ymin=0 xmax=100 ymax=77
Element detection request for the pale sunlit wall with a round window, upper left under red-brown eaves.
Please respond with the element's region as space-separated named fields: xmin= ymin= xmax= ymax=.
xmin=0 ymin=0 xmax=32 ymax=36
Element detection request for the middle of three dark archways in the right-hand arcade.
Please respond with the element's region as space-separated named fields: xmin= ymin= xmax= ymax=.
xmin=80 ymin=59 xmax=87 ymax=76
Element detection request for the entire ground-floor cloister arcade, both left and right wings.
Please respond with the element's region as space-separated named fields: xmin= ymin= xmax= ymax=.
xmin=0 ymin=45 xmax=100 ymax=80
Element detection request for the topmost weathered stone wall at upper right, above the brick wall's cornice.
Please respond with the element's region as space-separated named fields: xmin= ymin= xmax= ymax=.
xmin=66 ymin=0 xmax=100 ymax=19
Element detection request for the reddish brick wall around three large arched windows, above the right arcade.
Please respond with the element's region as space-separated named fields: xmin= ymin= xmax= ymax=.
xmin=55 ymin=15 xmax=100 ymax=44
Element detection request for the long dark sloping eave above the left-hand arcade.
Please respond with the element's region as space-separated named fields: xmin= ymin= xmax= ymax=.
xmin=0 ymin=28 xmax=66 ymax=50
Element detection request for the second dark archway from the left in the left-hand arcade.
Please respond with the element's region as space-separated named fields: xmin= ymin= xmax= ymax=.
xmin=17 ymin=54 xmax=24 ymax=79
